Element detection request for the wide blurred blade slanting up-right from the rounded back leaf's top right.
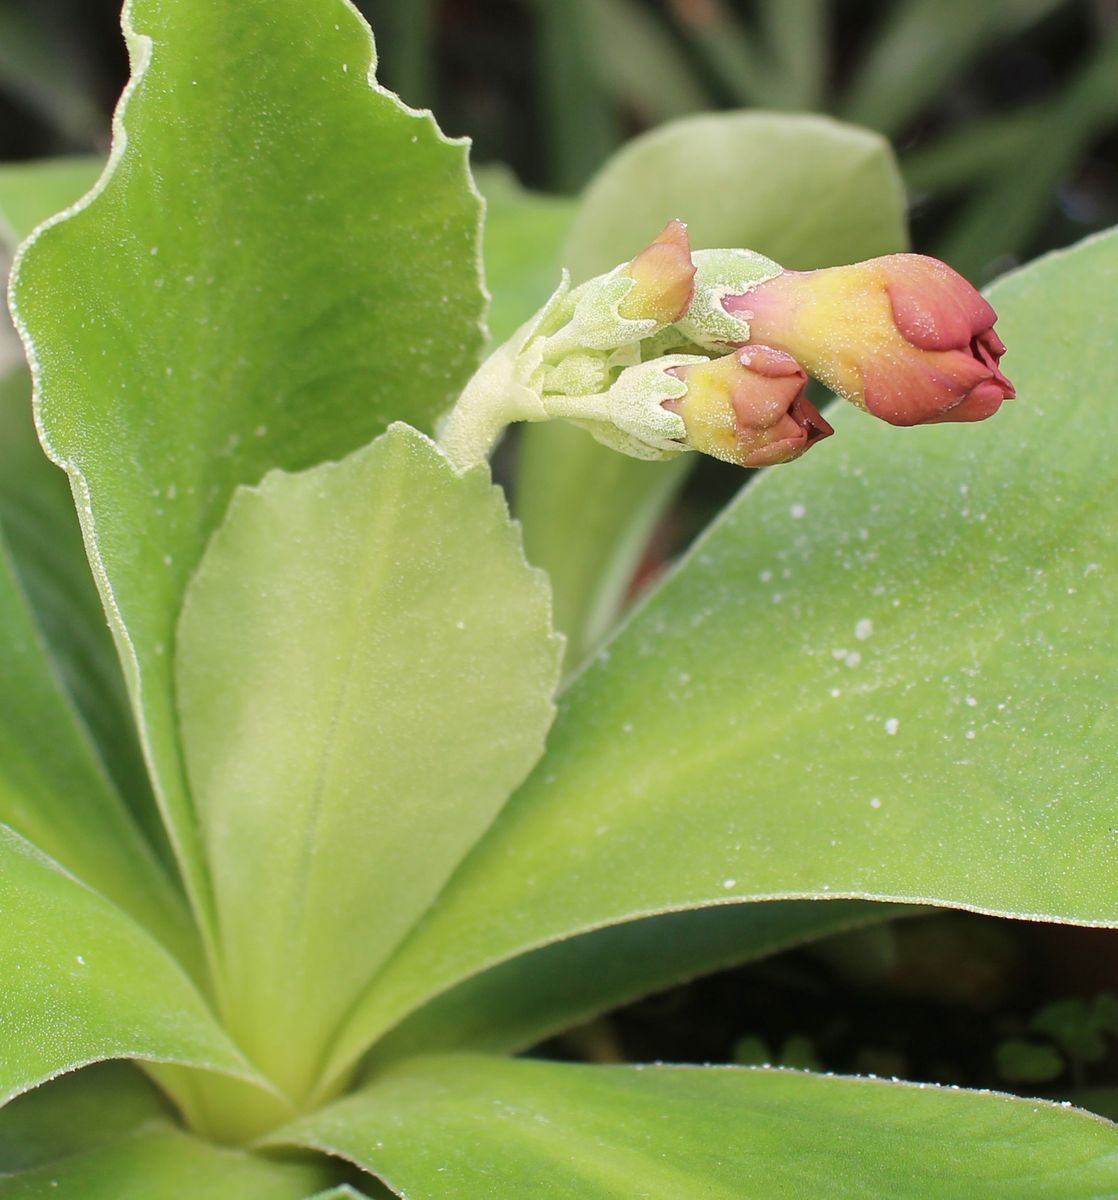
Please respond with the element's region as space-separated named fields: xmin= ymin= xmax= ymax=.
xmin=841 ymin=0 xmax=1065 ymax=133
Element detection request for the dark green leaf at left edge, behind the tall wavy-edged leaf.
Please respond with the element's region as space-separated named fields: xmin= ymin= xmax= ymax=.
xmin=0 ymin=367 xmax=166 ymax=854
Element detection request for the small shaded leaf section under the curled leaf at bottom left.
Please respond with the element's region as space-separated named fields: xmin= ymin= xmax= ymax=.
xmin=0 ymin=1062 xmax=169 ymax=1178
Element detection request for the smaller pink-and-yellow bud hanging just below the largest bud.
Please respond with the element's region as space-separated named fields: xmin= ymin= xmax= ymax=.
xmin=663 ymin=343 xmax=834 ymax=467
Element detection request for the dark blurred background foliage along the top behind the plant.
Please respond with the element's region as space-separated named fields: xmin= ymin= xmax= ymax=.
xmin=0 ymin=0 xmax=1118 ymax=282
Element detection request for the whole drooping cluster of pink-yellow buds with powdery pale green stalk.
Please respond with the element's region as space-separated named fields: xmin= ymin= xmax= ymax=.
xmin=440 ymin=221 xmax=1014 ymax=467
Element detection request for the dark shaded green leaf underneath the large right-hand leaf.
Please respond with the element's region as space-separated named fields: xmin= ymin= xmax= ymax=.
xmin=371 ymin=900 xmax=902 ymax=1069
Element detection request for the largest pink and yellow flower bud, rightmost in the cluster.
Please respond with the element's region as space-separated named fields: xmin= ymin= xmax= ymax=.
xmin=722 ymin=254 xmax=1015 ymax=425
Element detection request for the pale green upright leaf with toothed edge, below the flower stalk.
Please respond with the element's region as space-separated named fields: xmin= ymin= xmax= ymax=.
xmin=176 ymin=425 xmax=559 ymax=1094
